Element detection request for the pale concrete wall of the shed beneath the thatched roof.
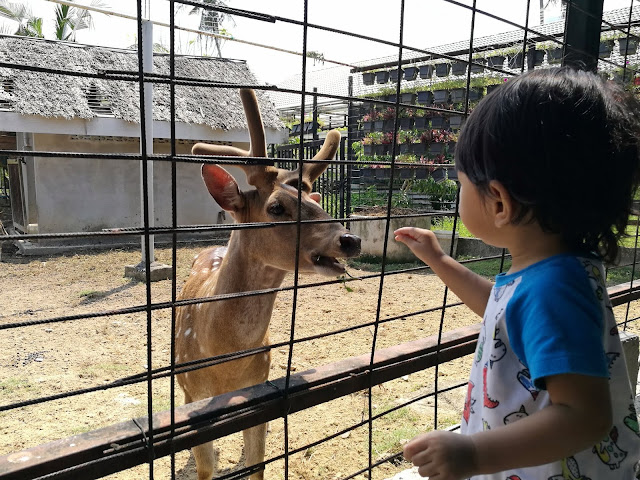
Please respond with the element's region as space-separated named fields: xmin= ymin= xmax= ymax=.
xmin=29 ymin=134 xmax=249 ymax=248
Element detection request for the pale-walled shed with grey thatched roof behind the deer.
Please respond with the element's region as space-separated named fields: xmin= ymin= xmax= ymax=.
xmin=0 ymin=36 xmax=286 ymax=253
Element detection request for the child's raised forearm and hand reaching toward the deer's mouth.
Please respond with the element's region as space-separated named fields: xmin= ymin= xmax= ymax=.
xmin=394 ymin=227 xmax=493 ymax=317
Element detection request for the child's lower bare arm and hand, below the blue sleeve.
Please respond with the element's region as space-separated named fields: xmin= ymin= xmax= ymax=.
xmin=404 ymin=374 xmax=611 ymax=480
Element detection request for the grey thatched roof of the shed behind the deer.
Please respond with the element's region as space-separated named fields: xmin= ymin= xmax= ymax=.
xmin=0 ymin=36 xmax=284 ymax=130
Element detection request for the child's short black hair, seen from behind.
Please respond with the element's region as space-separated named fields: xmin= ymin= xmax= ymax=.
xmin=456 ymin=67 xmax=640 ymax=262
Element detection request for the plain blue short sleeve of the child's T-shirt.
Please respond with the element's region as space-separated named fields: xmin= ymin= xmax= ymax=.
xmin=506 ymin=260 xmax=609 ymax=388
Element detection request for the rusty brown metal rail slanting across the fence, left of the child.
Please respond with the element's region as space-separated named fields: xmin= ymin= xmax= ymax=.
xmin=0 ymin=324 xmax=480 ymax=480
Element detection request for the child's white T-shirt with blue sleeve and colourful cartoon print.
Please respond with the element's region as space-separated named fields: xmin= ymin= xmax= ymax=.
xmin=461 ymin=255 xmax=640 ymax=480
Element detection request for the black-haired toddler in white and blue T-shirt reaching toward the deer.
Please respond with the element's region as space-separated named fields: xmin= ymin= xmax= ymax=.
xmin=395 ymin=68 xmax=640 ymax=480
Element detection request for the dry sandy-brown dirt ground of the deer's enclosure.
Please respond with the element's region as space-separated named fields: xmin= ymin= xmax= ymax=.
xmin=0 ymin=244 xmax=638 ymax=480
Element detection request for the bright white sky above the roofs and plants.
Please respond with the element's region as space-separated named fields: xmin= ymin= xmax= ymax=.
xmin=6 ymin=0 xmax=638 ymax=84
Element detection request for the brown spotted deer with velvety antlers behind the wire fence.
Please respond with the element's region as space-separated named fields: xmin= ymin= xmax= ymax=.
xmin=175 ymin=89 xmax=360 ymax=480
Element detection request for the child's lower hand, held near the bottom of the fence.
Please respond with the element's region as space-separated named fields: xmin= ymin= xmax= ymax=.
xmin=403 ymin=431 xmax=477 ymax=480
